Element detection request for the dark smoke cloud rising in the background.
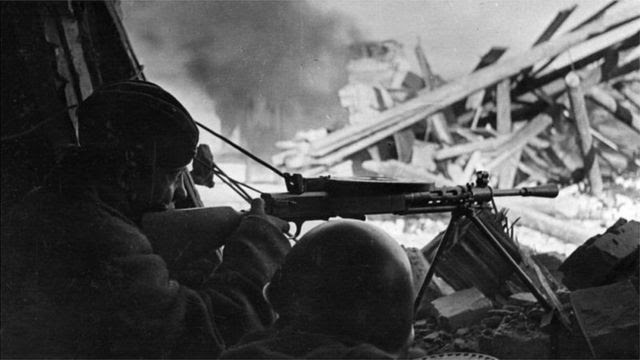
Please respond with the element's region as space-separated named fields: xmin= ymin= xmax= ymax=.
xmin=125 ymin=1 xmax=358 ymax=156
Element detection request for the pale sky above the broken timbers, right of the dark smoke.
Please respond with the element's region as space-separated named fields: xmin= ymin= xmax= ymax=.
xmin=313 ymin=0 xmax=620 ymax=79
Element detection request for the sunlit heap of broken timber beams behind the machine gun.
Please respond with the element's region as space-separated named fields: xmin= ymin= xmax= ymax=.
xmin=272 ymin=5 xmax=640 ymax=245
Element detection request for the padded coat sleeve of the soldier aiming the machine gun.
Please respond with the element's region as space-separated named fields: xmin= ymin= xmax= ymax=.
xmin=105 ymin=216 xmax=290 ymax=358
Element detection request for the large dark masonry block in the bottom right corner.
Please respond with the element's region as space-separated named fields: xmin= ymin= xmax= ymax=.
xmin=571 ymin=281 xmax=640 ymax=359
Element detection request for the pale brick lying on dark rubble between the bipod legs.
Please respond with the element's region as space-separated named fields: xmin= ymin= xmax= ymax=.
xmin=431 ymin=288 xmax=493 ymax=330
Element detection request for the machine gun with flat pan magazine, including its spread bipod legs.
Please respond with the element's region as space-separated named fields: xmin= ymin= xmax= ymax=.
xmin=262 ymin=171 xmax=569 ymax=326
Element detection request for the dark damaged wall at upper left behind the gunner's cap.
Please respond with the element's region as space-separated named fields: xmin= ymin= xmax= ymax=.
xmin=0 ymin=1 xmax=141 ymax=210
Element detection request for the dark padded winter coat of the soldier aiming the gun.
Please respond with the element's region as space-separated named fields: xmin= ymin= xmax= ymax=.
xmin=1 ymin=187 xmax=289 ymax=358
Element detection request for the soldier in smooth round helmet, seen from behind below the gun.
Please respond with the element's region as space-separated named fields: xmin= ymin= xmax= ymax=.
xmin=222 ymin=220 xmax=417 ymax=359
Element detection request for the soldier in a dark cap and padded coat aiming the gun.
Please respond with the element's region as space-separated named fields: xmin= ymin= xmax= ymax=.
xmin=2 ymin=81 xmax=290 ymax=358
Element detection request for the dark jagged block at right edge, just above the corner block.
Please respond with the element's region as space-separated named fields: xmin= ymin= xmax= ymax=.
xmin=560 ymin=219 xmax=640 ymax=290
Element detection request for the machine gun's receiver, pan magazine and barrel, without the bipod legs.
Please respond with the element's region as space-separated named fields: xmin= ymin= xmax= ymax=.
xmin=262 ymin=172 xmax=558 ymax=232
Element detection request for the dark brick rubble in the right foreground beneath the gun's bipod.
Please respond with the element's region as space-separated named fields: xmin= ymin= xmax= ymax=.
xmin=407 ymin=219 xmax=640 ymax=359
